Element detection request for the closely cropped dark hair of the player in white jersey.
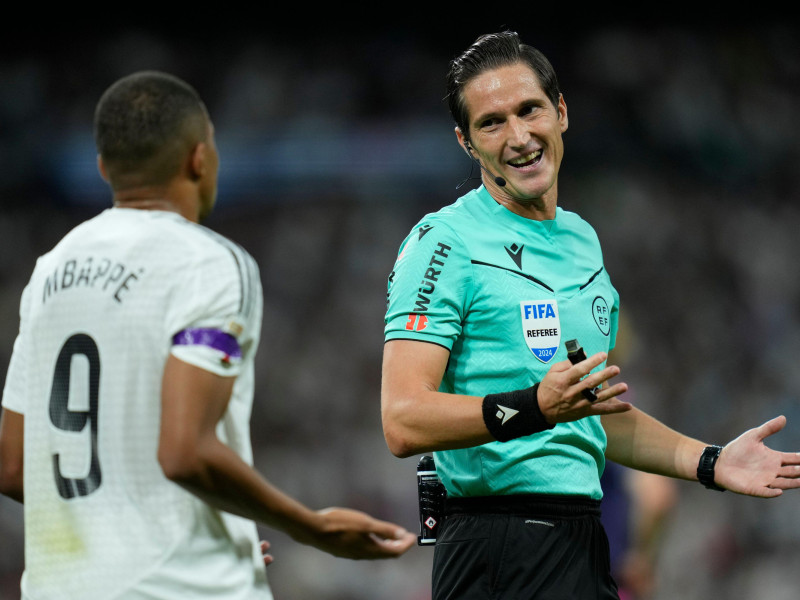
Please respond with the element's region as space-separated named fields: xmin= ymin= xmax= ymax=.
xmin=94 ymin=71 xmax=209 ymax=189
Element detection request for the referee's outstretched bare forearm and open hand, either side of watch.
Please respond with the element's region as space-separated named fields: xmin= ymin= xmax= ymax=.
xmin=602 ymin=409 xmax=800 ymax=498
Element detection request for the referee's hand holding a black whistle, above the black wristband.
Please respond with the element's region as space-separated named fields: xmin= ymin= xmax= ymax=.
xmin=538 ymin=352 xmax=632 ymax=425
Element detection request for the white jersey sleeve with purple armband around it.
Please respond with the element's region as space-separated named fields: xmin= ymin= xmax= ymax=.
xmin=167 ymin=242 xmax=262 ymax=376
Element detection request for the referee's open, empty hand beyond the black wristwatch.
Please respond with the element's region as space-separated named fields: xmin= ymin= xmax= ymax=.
xmin=714 ymin=416 xmax=800 ymax=498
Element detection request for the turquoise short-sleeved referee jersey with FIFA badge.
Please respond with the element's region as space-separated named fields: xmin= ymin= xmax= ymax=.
xmin=385 ymin=187 xmax=619 ymax=499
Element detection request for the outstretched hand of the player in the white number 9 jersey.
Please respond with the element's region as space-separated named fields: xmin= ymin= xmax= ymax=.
xmin=311 ymin=508 xmax=416 ymax=559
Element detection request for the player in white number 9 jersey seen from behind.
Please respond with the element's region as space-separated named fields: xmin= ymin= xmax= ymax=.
xmin=0 ymin=72 xmax=414 ymax=600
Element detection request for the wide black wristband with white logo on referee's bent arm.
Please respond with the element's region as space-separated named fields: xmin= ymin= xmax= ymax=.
xmin=483 ymin=383 xmax=555 ymax=442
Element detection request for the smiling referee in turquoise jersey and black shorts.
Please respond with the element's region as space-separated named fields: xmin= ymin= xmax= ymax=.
xmin=381 ymin=32 xmax=800 ymax=600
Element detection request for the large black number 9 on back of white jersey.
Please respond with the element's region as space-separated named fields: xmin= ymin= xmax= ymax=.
xmin=50 ymin=333 xmax=102 ymax=500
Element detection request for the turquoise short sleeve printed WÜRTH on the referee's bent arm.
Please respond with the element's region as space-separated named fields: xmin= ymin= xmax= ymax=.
xmin=384 ymin=220 xmax=472 ymax=350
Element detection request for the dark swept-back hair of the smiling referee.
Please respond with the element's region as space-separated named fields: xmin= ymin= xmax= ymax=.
xmin=447 ymin=31 xmax=561 ymax=140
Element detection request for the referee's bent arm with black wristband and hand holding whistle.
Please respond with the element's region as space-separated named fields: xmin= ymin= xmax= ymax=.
xmin=381 ymin=339 xmax=631 ymax=457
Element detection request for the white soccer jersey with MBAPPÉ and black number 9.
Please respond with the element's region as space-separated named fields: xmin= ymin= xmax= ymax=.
xmin=3 ymin=208 xmax=271 ymax=600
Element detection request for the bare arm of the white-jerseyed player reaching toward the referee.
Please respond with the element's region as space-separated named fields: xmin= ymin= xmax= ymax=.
xmin=158 ymin=355 xmax=415 ymax=558
